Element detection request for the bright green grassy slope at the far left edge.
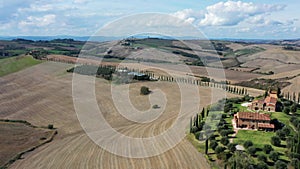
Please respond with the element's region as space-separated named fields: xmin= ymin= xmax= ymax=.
xmin=0 ymin=56 xmax=42 ymax=77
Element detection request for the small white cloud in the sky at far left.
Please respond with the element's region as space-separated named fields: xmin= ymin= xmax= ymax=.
xmin=19 ymin=14 xmax=56 ymax=27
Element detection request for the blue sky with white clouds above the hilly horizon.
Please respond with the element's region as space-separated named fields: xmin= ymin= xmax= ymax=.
xmin=0 ymin=0 xmax=300 ymax=39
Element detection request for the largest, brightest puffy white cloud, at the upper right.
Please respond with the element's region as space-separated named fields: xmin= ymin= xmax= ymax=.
xmin=199 ymin=1 xmax=285 ymax=26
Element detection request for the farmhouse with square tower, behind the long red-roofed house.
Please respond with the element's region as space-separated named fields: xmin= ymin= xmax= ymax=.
xmin=249 ymin=91 xmax=278 ymax=112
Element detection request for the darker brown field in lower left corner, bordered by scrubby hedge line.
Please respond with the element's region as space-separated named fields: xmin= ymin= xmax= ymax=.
xmin=0 ymin=121 xmax=52 ymax=168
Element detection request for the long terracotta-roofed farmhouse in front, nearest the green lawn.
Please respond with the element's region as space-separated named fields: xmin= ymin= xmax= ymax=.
xmin=234 ymin=112 xmax=275 ymax=130
